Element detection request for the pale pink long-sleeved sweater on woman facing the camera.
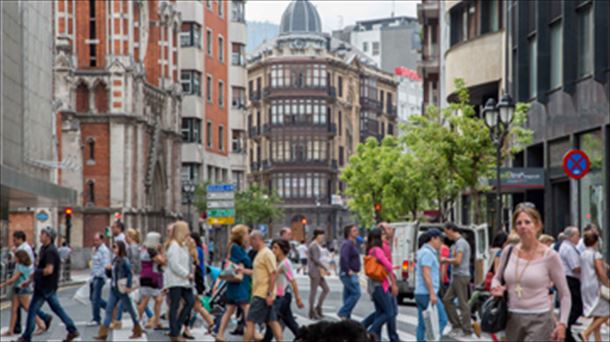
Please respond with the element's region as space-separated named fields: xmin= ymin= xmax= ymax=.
xmin=491 ymin=246 xmax=572 ymax=324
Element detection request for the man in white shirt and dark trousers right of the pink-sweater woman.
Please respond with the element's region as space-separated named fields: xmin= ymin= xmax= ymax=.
xmin=559 ymin=227 xmax=582 ymax=342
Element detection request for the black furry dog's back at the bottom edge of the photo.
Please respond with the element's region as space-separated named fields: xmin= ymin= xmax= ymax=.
xmin=295 ymin=320 xmax=375 ymax=342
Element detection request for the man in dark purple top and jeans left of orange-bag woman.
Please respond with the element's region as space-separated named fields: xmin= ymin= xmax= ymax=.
xmin=337 ymin=225 xmax=360 ymax=319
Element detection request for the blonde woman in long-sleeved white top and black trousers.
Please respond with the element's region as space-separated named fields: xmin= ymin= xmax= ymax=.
xmin=163 ymin=221 xmax=195 ymax=341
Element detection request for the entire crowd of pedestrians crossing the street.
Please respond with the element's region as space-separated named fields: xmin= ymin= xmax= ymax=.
xmin=0 ymin=204 xmax=610 ymax=341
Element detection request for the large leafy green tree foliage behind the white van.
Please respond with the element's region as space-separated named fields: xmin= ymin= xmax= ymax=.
xmin=341 ymin=79 xmax=533 ymax=225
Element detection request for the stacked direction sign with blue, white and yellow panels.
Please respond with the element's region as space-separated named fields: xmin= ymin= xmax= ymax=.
xmin=207 ymin=184 xmax=235 ymax=225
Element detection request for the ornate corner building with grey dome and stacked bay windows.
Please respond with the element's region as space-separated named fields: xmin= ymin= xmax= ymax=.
xmin=247 ymin=0 xmax=397 ymax=240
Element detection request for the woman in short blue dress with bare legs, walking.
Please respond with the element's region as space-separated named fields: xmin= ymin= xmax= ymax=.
xmin=216 ymin=224 xmax=252 ymax=341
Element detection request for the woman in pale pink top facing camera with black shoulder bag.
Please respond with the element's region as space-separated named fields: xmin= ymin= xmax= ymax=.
xmin=491 ymin=205 xmax=572 ymax=341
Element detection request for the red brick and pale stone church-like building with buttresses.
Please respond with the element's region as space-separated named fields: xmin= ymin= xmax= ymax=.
xmin=54 ymin=0 xmax=181 ymax=260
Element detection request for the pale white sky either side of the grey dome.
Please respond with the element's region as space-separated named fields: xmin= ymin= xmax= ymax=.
xmin=246 ymin=0 xmax=420 ymax=33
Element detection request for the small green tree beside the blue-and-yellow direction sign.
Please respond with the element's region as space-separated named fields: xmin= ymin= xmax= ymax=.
xmin=235 ymin=185 xmax=283 ymax=227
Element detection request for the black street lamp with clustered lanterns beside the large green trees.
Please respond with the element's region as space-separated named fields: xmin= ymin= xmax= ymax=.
xmin=483 ymin=94 xmax=515 ymax=232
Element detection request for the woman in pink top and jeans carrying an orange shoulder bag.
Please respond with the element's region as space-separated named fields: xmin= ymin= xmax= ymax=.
xmin=366 ymin=228 xmax=396 ymax=341
